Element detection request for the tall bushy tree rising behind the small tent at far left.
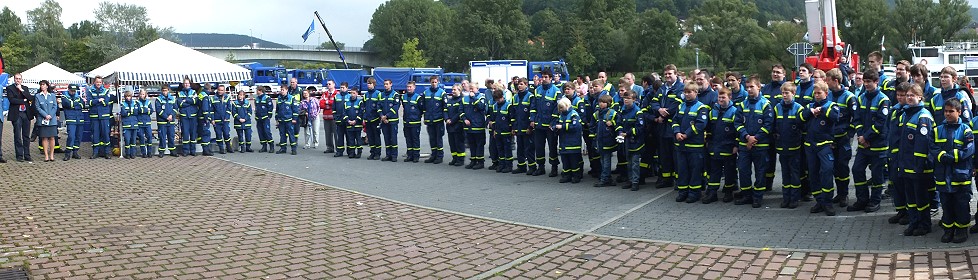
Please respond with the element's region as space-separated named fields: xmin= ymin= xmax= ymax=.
xmin=27 ymin=0 xmax=68 ymax=65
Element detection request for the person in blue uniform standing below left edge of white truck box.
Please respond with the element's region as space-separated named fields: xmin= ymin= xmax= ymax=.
xmin=460 ymin=84 xmax=488 ymax=170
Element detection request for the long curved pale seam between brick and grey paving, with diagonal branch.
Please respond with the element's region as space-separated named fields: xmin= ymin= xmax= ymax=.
xmin=213 ymin=157 xmax=978 ymax=254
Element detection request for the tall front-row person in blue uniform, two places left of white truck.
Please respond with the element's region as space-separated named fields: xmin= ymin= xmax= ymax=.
xmin=423 ymin=75 xmax=447 ymax=164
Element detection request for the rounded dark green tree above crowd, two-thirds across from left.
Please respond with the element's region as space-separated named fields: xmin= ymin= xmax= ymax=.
xmin=628 ymin=10 xmax=682 ymax=70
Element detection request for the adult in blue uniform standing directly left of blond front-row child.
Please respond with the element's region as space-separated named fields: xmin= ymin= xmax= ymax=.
xmin=530 ymin=70 xmax=560 ymax=177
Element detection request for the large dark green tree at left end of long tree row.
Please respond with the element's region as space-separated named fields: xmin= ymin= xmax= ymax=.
xmin=364 ymin=0 xmax=456 ymax=65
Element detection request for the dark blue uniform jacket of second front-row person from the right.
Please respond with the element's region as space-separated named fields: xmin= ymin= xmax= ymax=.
xmin=890 ymin=104 xmax=934 ymax=175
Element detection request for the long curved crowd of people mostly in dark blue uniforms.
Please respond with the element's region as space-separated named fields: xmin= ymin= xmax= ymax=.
xmin=0 ymin=52 xmax=978 ymax=243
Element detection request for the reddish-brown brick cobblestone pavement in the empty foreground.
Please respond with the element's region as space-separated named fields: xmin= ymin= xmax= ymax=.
xmin=0 ymin=128 xmax=978 ymax=279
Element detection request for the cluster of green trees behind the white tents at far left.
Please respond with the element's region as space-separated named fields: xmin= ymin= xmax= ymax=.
xmin=0 ymin=0 xmax=177 ymax=73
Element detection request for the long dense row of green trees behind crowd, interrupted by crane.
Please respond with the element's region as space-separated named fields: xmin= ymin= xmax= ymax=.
xmin=364 ymin=0 xmax=978 ymax=74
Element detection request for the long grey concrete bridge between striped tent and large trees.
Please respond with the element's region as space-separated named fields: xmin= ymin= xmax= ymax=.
xmin=193 ymin=46 xmax=384 ymax=67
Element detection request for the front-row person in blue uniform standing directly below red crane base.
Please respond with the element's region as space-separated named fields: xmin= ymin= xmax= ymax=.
xmin=801 ymin=82 xmax=840 ymax=216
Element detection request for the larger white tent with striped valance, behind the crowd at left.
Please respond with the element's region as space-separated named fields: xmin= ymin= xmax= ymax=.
xmin=85 ymin=39 xmax=251 ymax=85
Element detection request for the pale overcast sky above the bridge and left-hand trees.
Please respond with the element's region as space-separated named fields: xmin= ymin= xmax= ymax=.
xmin=2 ymin=0 xmax=386 ymax=47
